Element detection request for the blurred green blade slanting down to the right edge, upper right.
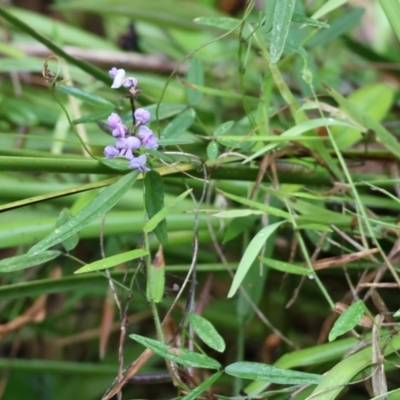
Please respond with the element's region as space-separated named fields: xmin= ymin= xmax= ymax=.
xmin=326 ymin=87 xmax=400 ymax=158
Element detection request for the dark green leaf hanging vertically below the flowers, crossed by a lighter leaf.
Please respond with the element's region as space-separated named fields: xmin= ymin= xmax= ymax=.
xmin=144 ymin=170 xmax=168 ymax=244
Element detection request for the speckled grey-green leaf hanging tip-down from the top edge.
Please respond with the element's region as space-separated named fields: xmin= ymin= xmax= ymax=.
xmin=270 ymin=0 xmax=295 ymax=64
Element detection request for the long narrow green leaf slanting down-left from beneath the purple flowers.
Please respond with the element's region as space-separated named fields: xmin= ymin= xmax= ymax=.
xmin=28 ymin=171 xmax=139 ymax=254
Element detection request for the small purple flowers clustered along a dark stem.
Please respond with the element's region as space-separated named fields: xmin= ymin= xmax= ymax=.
xmin=104 ymin=67 xmax=158 ymax=172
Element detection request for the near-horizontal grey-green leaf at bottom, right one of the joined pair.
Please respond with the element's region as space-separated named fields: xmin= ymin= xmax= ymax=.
xmin=225 ymin=361 xmax=322 ymax=385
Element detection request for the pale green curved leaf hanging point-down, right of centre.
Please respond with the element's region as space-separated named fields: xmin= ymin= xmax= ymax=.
xmin=228 ymin=221 xmax=285 ymax=297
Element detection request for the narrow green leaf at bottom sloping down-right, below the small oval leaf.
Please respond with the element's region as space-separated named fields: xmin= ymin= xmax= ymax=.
xmin=129 ymin=334 xmax=221 ymax=369
